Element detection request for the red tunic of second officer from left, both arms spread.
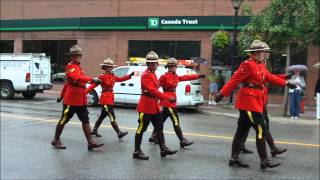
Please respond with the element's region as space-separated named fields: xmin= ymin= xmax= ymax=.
xmin=86 ymin=73 xmax=131 ymax=105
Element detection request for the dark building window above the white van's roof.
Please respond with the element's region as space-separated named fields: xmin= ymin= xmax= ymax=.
xmin=128 ymin=40 xmax=201 ymax=59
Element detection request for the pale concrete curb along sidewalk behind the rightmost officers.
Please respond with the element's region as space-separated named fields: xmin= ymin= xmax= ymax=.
xmin=199 ymin=109 xmax=320 ymax=126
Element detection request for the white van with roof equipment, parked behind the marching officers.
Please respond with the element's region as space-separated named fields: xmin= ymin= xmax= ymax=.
xmin=88 ymin=65 xmax=203 ymax=107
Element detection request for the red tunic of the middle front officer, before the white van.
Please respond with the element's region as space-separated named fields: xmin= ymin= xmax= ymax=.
xmin=137 ymin=69 xmax=170 ymax=114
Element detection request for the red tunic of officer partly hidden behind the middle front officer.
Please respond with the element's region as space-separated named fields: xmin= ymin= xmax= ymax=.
xmin=159 ymin=72 xmax=199 ymax=108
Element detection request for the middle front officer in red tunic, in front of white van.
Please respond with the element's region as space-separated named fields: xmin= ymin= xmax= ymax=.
xmin=133 ymin=51 xmax=177 ymax=160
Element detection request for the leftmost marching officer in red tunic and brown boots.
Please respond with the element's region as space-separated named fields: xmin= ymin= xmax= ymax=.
xmin=51 ymin=45 xmax=103 ymax=150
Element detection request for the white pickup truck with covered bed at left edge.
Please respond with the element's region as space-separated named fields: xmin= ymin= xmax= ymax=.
xmin=0 ymin=53 xmax=52 ymax=99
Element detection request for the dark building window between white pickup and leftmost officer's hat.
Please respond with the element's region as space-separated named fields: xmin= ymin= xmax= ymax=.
xmin=22 ymin=40 xmax=77 ymax=74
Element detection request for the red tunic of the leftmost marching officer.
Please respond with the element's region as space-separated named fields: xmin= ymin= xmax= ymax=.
xmin=63 ymin=62 xmax=92 ymax=106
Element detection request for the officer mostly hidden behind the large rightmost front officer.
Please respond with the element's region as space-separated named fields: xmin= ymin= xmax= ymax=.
xmin=241 ymin=42 xmax=292 ymax=157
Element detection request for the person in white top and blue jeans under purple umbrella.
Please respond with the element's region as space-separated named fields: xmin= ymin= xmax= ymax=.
xmin=289 ymin=70 xmax=306 ymax=119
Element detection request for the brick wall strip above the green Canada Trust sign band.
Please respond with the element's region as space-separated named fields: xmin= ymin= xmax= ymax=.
xmin=0 ymin=0 xmax=270 ymax=19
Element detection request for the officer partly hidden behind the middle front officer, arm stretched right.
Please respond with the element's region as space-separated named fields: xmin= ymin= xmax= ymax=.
xmin=149 ymin=58 xmax=205 ymax=147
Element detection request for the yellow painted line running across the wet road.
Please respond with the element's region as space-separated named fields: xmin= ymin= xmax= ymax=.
xmin=0 ymin=113 xmax=320 ymax=147
